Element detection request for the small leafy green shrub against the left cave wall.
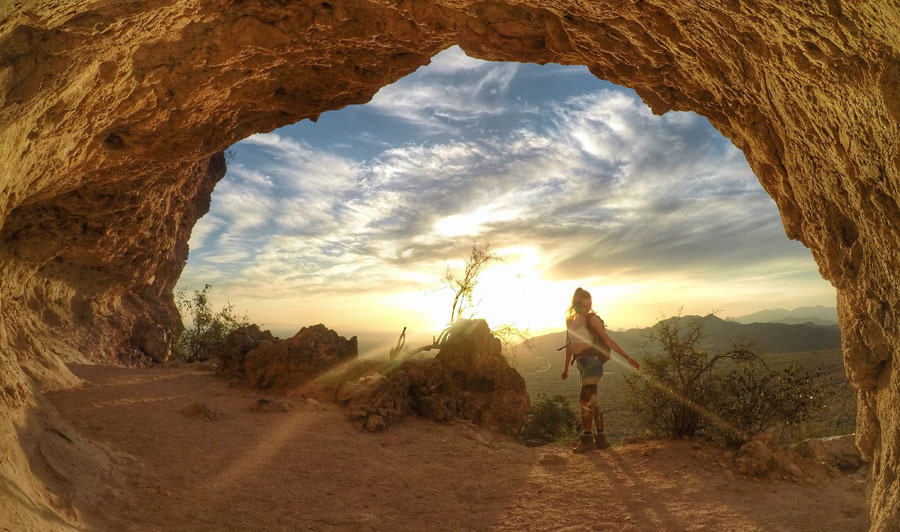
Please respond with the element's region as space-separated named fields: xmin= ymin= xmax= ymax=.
xmin=174 ymin=284 xmax=249 ymax=362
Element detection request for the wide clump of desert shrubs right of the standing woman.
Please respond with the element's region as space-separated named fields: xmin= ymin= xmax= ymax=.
xmin=626 ymin=316 xmax=823 ymax=445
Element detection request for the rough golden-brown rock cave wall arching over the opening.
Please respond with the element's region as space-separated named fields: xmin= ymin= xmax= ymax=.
xmin=0 ymin=0 xmax=900 ymax=530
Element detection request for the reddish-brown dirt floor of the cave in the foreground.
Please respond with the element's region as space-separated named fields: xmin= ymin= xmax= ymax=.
xmin=48 ymin=366 xmax=868 ymax=532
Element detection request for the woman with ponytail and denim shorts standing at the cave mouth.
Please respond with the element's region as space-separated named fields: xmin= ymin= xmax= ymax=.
xmin=562 ymin=287 xmax=640 ymax=453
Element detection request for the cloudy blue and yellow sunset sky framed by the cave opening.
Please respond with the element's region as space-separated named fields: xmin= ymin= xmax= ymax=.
xmin=179 ymin=47 xmax=835 ymax=335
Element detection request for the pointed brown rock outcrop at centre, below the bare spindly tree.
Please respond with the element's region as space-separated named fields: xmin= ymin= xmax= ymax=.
xmin=337 ymin=320 xmax=530 ymax=434
